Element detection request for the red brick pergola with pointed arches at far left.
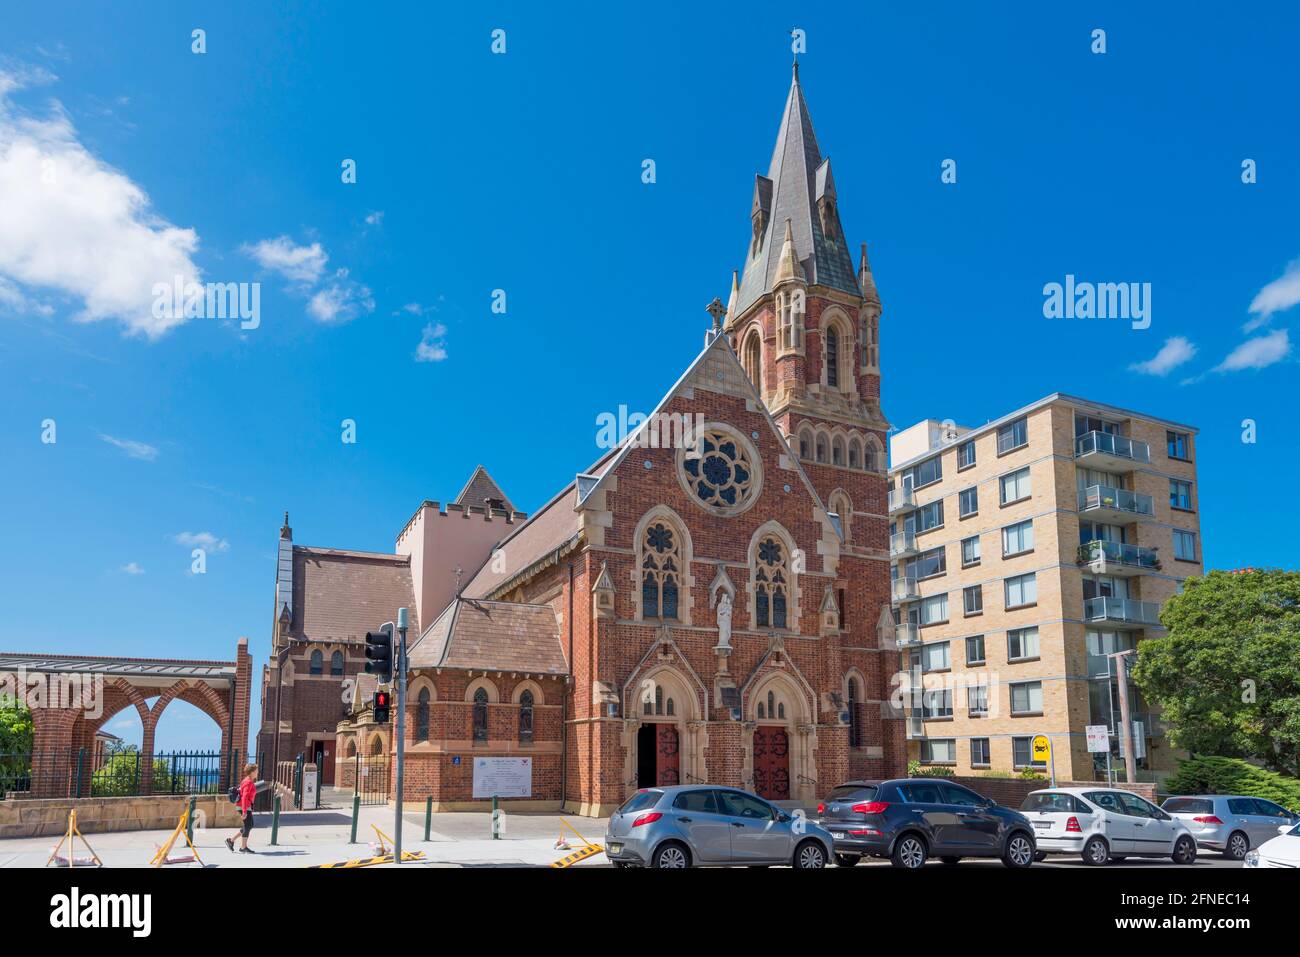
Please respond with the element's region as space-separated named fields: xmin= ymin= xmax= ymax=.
xmin=0 ymin=638 xmax=252 ymax=797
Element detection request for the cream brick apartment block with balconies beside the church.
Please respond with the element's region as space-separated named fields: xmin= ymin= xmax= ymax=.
xmin=889 ymin=394 xmax=1201 ymax=780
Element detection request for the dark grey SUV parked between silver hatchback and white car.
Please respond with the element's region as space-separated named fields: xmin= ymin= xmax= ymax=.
xmin=818 ymin=778 xmax=1036 ymax=870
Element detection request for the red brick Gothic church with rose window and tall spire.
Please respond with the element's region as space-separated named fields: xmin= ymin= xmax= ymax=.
xmin=257 ymin=69 xmax=905 ymax=814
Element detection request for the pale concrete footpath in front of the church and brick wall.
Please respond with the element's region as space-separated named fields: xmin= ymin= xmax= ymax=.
xmin=0 ymin=806 xmax=608 ymax=870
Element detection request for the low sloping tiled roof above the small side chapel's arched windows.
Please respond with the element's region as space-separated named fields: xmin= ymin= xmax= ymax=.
xmin=408 ymin=598 xmax=568 ymax=675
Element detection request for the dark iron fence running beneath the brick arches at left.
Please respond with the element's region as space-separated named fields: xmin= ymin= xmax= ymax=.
xmin=0 ymin=748 xmax=253 ymax=800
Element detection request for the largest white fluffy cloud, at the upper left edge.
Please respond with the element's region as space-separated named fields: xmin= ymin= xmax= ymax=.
xmin=0 ymin=65 xmax=200 ymax=339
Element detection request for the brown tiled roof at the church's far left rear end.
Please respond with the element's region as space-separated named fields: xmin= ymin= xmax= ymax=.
xmin=290 ymin=545 xmax=420 ymax=641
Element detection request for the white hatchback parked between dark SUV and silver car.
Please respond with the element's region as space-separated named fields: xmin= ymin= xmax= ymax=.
xmin=1021 ymin=787 xmax=1196 ymax=865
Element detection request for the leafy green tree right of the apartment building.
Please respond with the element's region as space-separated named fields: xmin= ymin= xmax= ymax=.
xmin=1134 ymin=568 xmax=1300 ymax=776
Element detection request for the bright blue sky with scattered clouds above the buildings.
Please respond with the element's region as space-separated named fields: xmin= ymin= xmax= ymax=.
xmin=0 ymin=1 xmax=1300 ymax=746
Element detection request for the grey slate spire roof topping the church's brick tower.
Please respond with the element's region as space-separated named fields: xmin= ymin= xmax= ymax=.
xmin=728 ymin=68 xmax=862 ymax=320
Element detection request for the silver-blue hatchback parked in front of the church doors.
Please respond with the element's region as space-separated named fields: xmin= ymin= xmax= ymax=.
xmin=605 ymin=784 xmax=835 ymax=869
